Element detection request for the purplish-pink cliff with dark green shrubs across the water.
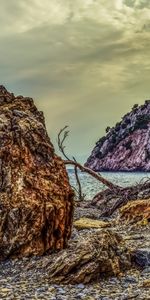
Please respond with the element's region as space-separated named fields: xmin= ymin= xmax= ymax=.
xmin=85 ymin=100 xmax=150 ymax=171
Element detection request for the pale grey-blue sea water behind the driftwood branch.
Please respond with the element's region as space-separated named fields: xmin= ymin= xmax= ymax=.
xmin=68 ymin=169 xmax=150 ymax=200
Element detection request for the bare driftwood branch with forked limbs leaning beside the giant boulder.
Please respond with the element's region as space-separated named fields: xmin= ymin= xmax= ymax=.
xmin=58 ymin=126 xmax=150 ymax=217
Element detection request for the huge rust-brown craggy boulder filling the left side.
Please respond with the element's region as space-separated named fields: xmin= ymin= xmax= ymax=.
xmin=0 ymin=86 xmax=73 ymax=260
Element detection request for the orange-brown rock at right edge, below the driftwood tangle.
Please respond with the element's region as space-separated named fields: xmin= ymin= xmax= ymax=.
xmin=119 ymin=199 xmax=150 ymax=225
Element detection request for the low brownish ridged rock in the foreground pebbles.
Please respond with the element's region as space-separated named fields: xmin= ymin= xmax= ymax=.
xmin=46 ymin=229 xmax=131 ymax=284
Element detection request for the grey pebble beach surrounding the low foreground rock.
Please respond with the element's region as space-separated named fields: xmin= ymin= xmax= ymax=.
xmin=0 ymin=202 xmax=150 ymax=300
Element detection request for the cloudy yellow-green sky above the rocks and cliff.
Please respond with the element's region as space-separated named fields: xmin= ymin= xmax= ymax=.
xmin=0 ymin=0 xmax=150 ymax=163
